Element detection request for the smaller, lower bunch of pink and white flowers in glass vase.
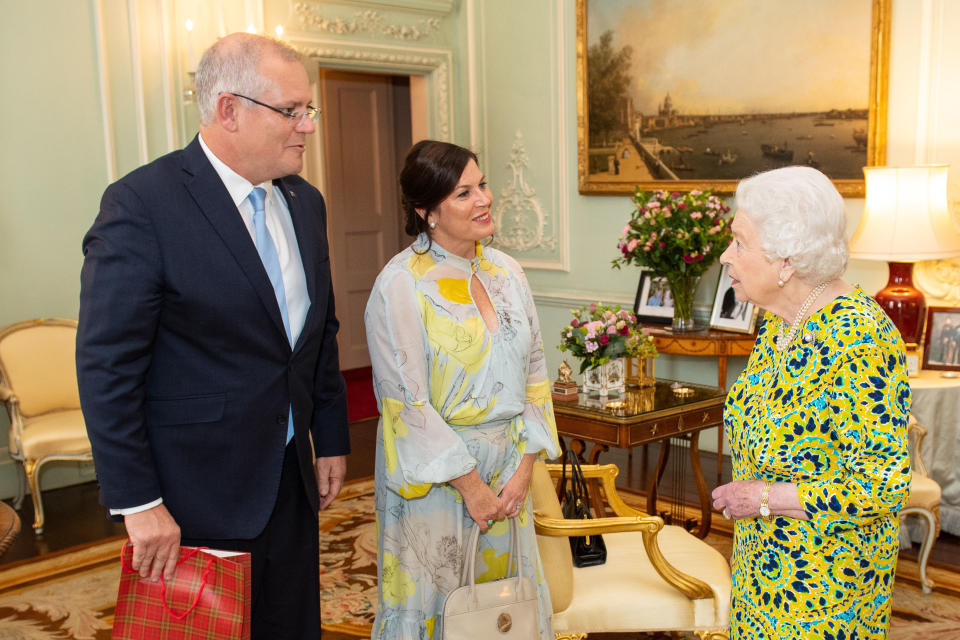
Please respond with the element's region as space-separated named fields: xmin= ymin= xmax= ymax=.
xmin=559 ymin=302 xmax=657 ymax=373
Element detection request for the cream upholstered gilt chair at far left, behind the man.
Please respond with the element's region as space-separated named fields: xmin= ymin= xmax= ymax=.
xmin=0 ymin=318 xmax=93 ymax=533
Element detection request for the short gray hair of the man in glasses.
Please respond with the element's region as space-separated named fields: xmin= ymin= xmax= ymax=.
xmin=196 ymin=33 xmax=300 ymax=125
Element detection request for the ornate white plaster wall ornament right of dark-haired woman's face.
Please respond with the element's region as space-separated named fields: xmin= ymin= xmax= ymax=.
xmin=493 ymin=131 xmax=557 ymax=251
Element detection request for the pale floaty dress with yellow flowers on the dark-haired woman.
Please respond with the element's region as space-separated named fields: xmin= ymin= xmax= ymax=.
xmin=364 ymin=235 xmax=560 ymax=640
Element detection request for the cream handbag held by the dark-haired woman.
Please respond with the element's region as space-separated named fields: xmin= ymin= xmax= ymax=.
xmin=440 ymin=518 xmax=540 ymax=640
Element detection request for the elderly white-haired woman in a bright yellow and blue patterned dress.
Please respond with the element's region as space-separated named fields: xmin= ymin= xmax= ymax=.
xmin=713 ymin=167 xmax=910 ymax=640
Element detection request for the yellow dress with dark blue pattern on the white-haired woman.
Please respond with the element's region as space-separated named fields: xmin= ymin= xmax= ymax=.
xmin=724 ymin=287 xmax=910 ymax=640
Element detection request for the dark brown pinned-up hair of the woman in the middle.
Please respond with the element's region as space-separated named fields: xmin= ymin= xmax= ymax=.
xmin=400 ymin=140 xmax=479 ymax=236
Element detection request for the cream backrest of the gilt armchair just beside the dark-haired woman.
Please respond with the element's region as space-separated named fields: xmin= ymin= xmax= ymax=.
xmin=530 ymin=461 xmax=573 ymax=612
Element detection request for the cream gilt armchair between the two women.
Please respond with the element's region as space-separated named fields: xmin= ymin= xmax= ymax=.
xmin=530 ymin=462 xmax=731 ymax=640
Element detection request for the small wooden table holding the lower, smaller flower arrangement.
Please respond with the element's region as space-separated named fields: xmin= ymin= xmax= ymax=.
xmin=553 ymin=380 xmax=726 ymax=538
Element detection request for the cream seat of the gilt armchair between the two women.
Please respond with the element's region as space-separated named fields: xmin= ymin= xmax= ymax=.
xmin=551 ymin=526 xmax=731 ymax=633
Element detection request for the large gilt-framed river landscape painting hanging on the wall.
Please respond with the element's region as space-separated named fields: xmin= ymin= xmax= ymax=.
xmin=576 ymin=0 xmax=892 ymax=197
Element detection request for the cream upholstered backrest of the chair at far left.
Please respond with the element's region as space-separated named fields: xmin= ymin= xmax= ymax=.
xmin=0 ymin=325 xmax=80 ymax=416
